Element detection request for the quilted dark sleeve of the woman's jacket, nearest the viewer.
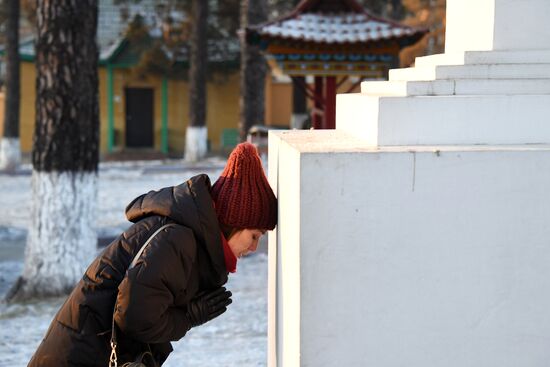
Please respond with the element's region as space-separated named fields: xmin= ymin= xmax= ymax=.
xmin=114 ymin=226 xmax=197 ymax=343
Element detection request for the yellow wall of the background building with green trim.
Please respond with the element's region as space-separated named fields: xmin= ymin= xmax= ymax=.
xmin=9 ymin=62 xmax=358 ymax=154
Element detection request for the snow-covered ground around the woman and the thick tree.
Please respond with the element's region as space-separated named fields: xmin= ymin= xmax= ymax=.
xmin=0 ymin=158 xmax=267 ymax=367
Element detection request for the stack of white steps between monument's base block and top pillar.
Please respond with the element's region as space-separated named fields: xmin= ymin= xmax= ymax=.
xmin=336 ymin=50 xmax=550 ymax=146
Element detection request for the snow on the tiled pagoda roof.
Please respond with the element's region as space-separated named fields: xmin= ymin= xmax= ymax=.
xmin=256 ymin=13 xmax=416 ymax=43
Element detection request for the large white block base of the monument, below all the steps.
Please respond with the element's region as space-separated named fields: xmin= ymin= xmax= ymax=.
xmin=269 ymin=131 xmax=550 ymax=367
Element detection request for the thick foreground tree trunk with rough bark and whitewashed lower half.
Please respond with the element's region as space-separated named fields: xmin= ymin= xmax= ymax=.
xmin=7 ymin=0 xmax=99 ymax=301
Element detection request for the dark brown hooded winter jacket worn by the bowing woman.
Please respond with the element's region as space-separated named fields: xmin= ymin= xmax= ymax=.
xmin=29 ymin=175 xmax=227 ymax=367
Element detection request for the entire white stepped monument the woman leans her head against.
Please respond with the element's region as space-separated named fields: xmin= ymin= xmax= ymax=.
xmin=268 ymin=0 xmax=550 ymax=367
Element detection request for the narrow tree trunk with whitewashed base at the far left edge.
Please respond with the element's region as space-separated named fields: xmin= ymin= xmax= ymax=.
xmin=0 ymin=0 xmax=21 ymax=171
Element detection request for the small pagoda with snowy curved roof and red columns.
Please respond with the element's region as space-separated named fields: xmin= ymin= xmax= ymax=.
xmin=246 ymin=0 xmax=426 ymax=129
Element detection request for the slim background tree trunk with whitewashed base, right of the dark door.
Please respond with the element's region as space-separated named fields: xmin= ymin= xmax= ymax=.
xmin=185 ymin=0 xmax=208 ymax=162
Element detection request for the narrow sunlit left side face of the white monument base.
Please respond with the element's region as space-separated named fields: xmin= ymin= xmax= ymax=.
xmin=268 ymin=134 xmax=301 ymax=366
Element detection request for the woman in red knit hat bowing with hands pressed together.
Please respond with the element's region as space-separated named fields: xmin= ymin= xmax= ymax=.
xmin=29 ymin=143 xmax=277 ymax=367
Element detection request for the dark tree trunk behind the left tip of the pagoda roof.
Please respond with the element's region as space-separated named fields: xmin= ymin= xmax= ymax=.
xmin=239 ymin=0 xmax=267 ymax=141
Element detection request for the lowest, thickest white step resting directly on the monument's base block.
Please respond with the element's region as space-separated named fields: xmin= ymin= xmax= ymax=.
xmin=336 ymin=93 xmax=550 ymax=146
